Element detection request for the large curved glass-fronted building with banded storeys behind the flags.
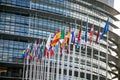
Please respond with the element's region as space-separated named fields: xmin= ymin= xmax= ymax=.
xmin=0 ymin=0 xmax=120 ymax=80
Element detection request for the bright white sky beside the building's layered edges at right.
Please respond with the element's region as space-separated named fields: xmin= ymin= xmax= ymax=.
xmin=113 ymin=0 xmax=120 ymax=36
